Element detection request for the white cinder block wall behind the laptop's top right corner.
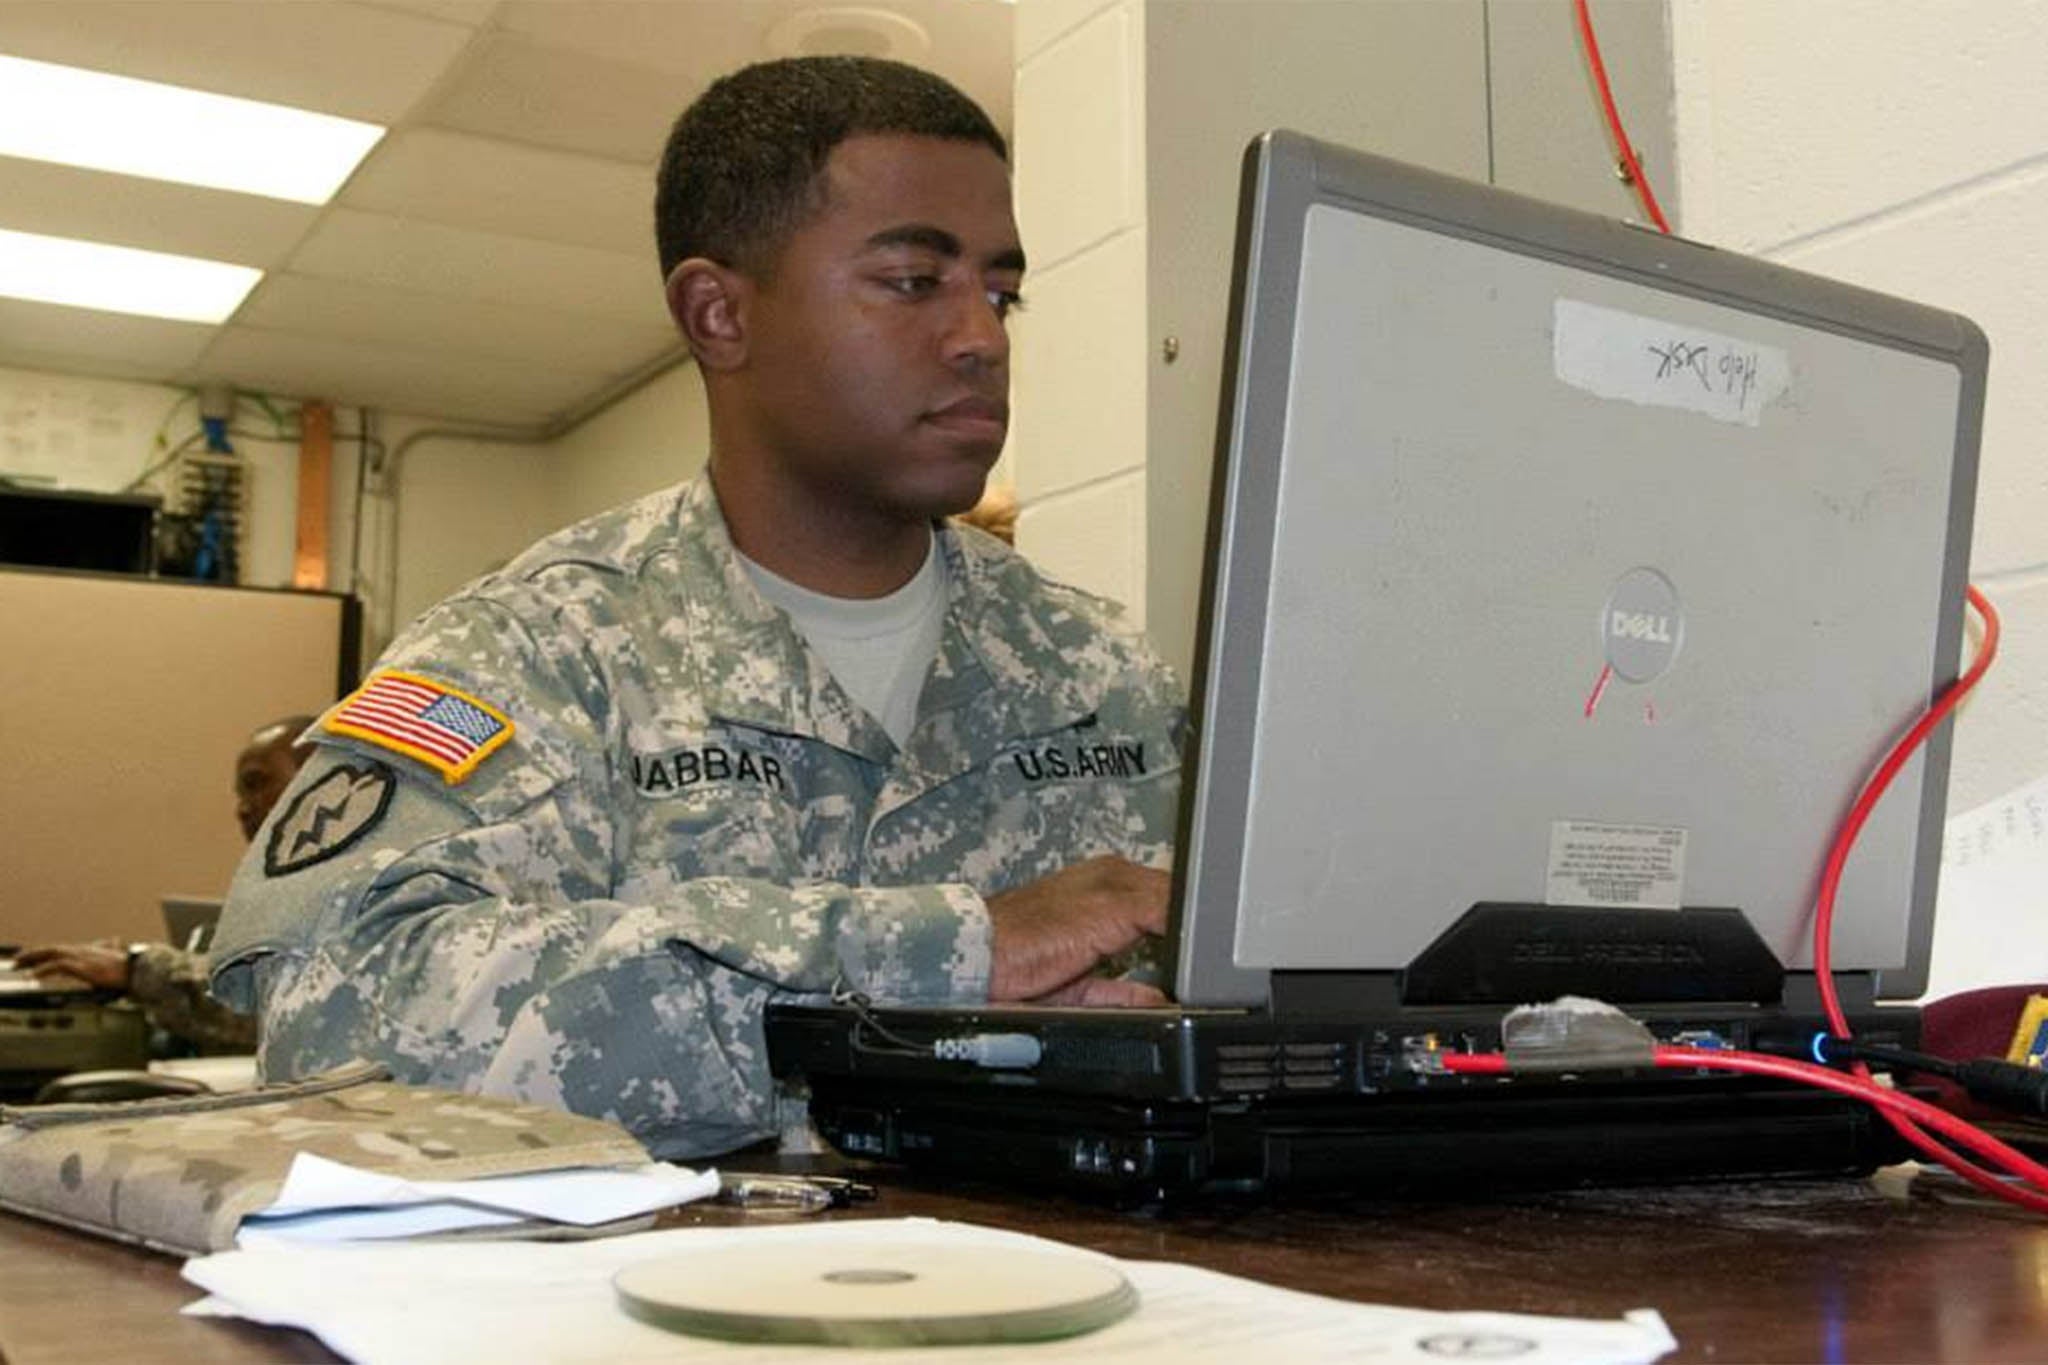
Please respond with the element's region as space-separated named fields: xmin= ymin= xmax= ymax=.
xmin=1671 ymin=0 xmax=2048 ymax=812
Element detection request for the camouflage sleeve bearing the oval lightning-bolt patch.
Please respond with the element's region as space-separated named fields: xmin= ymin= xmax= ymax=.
xmin=215 ymin=597 xmax=991 ymax=1156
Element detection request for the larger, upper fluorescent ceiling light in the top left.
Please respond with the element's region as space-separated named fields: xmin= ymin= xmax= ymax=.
xmin=0 ymin=57 xmax=383 ymax=205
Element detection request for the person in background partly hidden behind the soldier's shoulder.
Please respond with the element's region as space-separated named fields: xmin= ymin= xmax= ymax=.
xmin=14 ymin=716 xmax=313 ymax=1054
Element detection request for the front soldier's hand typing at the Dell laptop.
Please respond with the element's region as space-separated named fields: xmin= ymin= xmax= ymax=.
xmin=989 ymin=855 xmax=1174 ymax=1005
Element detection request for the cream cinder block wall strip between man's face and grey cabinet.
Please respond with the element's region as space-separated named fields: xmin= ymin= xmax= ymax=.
xmin=1006 ymin=0 xmax=1147 ymax=626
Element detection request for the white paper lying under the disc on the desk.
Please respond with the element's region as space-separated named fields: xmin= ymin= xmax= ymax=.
xmin=184 ymin=1220 xmax=1677 ymax=1365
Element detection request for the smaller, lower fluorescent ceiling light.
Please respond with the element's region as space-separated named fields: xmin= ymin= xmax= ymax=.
xmin=0 ymin=229 xmax=262 ymax=323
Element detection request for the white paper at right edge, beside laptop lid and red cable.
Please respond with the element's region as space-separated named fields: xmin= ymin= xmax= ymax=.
xmin=1921 ymin=778 xmax=2048 ymax=1001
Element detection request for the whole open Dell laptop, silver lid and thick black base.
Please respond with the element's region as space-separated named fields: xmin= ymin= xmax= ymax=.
xmin=768 ymin=131 xmax=1987 ymax=1197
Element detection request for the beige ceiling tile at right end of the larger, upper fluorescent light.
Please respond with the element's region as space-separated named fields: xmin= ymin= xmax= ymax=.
xmin=338 ymin=129 xmax=653 ymax=262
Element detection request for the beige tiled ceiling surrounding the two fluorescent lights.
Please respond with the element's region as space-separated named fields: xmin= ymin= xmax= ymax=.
xmin=0 ymin=0 xmax=1014 ymax=424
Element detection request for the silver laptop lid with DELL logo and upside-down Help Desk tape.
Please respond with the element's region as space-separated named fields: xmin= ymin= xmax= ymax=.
xmin=1176 ymin=133 xmax=1987 ymax=1005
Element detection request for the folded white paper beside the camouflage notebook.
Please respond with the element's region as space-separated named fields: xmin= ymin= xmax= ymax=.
xmin=236 ymin=1152 xmax=719 ymax=1246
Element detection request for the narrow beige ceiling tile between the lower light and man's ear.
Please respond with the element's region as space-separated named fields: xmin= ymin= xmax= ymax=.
xmin=236 ymin=274 xmax=678 ymax=372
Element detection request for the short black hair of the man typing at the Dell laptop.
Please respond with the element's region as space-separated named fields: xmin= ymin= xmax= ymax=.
xmin=653 ymin=57 xmax=1010 ymax=278
